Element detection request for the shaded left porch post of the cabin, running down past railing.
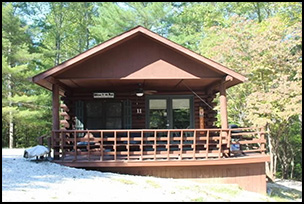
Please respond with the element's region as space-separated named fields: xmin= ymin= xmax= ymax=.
xmin=52 ymin=84 xmax=59 ymax=159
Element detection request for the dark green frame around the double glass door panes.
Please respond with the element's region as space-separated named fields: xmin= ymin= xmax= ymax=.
xmin=145 ymin=95 xmax=194 ymax=129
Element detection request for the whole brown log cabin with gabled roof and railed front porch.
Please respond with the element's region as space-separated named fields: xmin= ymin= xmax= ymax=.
xmin=32 ymin=26 xmax=269 ymax=194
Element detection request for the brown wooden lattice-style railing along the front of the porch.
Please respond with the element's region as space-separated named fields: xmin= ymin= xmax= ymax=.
xmin=52 ymin=128 xmax=266 ymax=161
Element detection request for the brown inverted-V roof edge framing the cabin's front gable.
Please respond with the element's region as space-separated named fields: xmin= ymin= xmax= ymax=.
xmin=32 ymin=26 xmax=246 ymax=90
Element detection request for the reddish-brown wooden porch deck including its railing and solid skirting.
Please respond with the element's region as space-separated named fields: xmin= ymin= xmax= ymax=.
xmin=48 ymin=128 xmax=270 ymax=194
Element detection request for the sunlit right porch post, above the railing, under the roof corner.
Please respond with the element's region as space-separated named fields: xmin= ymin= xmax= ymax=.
xmin=220 ymin=79 xmax=228 ymax=129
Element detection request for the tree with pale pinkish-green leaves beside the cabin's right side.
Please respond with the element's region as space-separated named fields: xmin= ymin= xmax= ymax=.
xmin=200 ymin=17 xmax=302 ymax=181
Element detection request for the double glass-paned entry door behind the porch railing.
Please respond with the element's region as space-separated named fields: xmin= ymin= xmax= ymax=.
xmin=146 ymin=96 xmax=193 ymax=129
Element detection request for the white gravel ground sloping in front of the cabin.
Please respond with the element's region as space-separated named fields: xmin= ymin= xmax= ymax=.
xmin=2 ymin=149 xmax=302 ymax=202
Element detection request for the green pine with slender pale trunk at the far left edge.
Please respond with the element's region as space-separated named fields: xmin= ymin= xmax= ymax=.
xmin=2 ymin=3 xmax=49 ymax=148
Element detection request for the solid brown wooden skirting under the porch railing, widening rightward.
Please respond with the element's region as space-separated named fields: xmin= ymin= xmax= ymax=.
xmin=56 ymin=155 xmax=269 ymax=194
